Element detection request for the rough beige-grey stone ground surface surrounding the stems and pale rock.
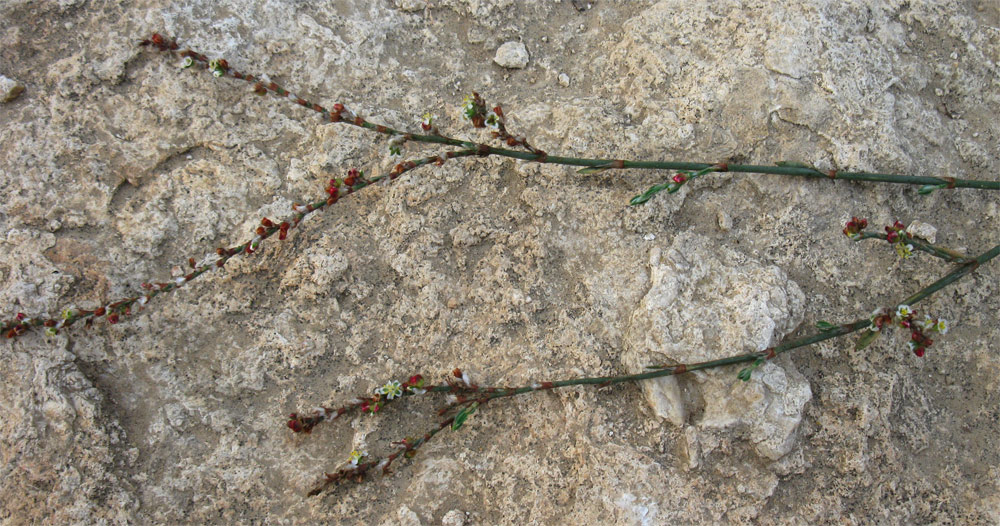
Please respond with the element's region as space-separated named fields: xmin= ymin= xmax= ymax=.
xmin=0 ymin=0 xmax=1000 ymax=524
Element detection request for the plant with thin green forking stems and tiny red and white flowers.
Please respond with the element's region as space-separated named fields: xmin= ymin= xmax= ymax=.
xmin=0 ymin=34 xmax=1000 ymax=500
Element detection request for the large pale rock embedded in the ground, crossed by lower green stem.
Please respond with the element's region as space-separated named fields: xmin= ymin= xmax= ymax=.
xmin=622 ymin=233 xmax=812 ymax=462
